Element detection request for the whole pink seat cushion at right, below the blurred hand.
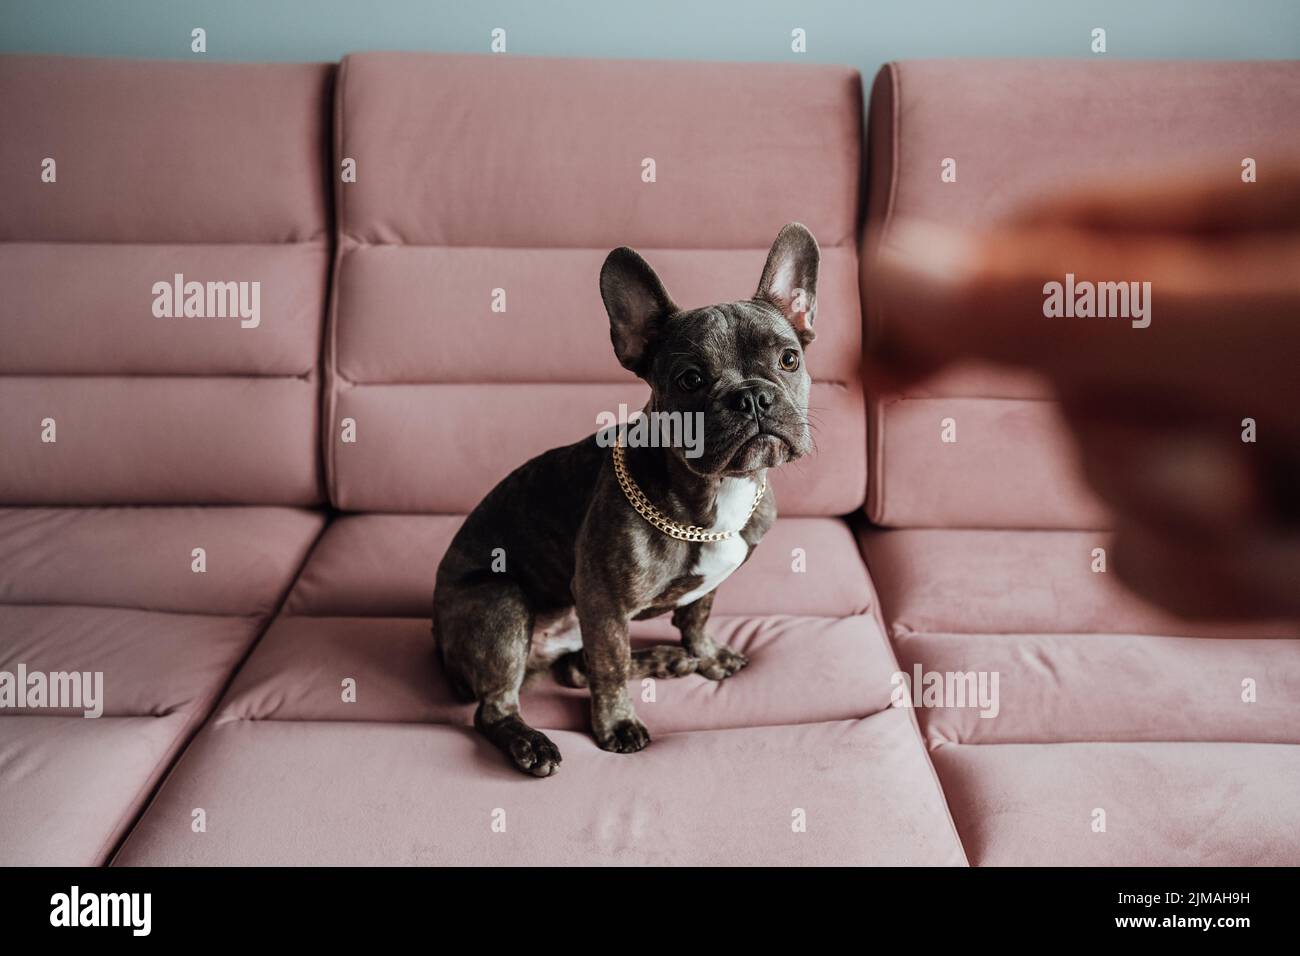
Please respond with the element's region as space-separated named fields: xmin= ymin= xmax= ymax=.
xmin=859 ymin=529 xmax=1300 ymax=866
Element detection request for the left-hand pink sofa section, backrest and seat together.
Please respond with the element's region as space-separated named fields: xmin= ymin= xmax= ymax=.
xmin=0 ymin=56 xmax=333 ymax=865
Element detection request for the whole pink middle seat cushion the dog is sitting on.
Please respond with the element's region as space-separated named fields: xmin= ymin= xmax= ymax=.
xmin=117 ymin=515 xmax=963 ymax=865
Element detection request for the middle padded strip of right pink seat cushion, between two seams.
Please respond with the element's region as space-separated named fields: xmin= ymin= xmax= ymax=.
xmin=894 ymin=633 xmax=1300 ymax=749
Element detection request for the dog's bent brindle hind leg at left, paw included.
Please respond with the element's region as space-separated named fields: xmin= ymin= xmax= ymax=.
xmin=434 ymin=579 xmax=560 ymax=777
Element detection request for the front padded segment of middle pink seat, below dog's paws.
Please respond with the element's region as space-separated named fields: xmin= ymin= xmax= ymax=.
xmin=116 ymin=711 xmax=965 ymax=866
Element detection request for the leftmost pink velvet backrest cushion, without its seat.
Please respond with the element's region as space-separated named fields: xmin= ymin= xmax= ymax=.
xmin=0 ymin=56 xmax=333 ymax=505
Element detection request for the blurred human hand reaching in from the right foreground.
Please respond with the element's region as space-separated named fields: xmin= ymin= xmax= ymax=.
xmin=867 ymin=165 xmax=1300 ymax=618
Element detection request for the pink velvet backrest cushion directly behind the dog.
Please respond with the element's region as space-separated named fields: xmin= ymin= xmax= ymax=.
xmin=325 ymin=53 xmax=866 ymax=514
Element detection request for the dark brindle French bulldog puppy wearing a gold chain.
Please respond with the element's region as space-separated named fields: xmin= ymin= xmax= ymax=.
xmin=433 ymin=222 xmax=820 ymax=777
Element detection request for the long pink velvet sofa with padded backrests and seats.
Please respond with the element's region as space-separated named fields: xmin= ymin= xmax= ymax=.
xmin=0 ymin=55 xmax=1300 ymax=865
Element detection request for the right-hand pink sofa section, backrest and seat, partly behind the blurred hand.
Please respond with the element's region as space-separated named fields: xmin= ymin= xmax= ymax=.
xmin=859 ymin=60 xmax=1300 ymax=866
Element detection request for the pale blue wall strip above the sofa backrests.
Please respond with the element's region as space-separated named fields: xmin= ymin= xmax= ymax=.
xmin=0 ymin=0 xmax=1300 ymax=81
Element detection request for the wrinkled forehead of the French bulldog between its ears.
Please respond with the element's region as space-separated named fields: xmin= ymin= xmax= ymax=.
xmin=655 ymin=302 xmax=800 ymax=368
